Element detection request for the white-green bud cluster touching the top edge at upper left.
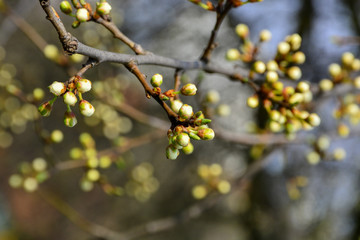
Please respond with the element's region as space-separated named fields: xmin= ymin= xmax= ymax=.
xmin=60 ymin=0 xmax=111 ymax=28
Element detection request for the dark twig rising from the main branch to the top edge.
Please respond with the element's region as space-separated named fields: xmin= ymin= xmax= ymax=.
xmin=200 ymin=1 xmax=232 ymax=62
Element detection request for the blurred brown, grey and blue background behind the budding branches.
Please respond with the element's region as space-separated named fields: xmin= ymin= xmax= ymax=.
xmin=0 ymin=0 xmax=360 ymax=240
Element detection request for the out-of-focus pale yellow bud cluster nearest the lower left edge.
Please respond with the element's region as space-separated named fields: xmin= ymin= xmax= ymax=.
xmin=9 ymin=158 xmax=49 ymax=192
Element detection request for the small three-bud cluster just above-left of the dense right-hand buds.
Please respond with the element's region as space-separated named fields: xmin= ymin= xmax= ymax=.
xmin=226 ymin=23 xmax=271 ymax=63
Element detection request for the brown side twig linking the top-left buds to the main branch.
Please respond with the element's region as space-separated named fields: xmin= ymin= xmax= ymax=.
xmin=95 ymin=17 xmax=150 ymax=55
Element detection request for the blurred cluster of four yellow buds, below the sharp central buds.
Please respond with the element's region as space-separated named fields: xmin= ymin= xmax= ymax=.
xmin=192 ymin=163 xmax=231 ymax=199
